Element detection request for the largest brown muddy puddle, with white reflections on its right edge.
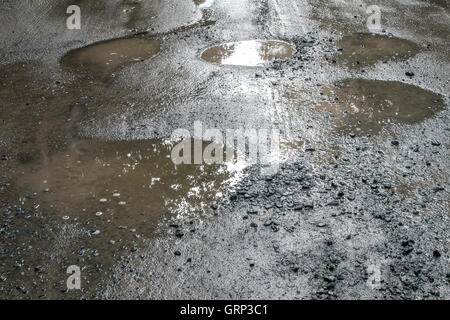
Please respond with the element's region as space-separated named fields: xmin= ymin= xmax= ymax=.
xmin=15 ymin=139 xmax=230 ymax=234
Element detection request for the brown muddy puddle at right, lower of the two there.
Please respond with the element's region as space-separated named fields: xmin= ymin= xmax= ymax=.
xmin=316 ymin=79 xmax=445 ymax=135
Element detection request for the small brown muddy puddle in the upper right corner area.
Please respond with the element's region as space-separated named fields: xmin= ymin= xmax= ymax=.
xmin=334 ymin=33 xmax=420 ymax=69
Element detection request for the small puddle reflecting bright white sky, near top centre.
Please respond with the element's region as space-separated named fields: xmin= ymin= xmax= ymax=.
xmin=201 ymin=40 xmax=294 ymax=67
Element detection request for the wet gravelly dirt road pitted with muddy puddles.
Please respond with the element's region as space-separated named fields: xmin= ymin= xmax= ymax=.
xmin=0 ymin=0 xmax=450 ymax=299
